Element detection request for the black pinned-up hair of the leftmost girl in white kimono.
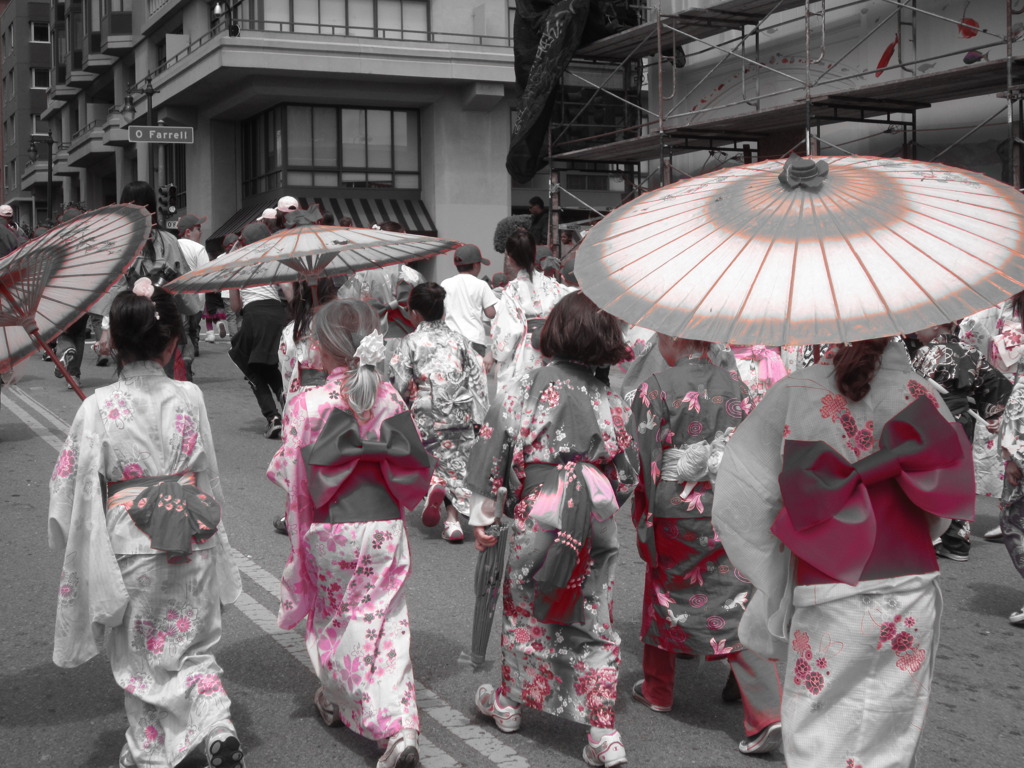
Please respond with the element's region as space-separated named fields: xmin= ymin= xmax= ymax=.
xmin=111 ymin=288 xmax=181 ymax=366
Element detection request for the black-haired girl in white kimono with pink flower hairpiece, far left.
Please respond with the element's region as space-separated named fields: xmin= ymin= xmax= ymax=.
xmin=49 ymin=278 xmax=243 ymax=768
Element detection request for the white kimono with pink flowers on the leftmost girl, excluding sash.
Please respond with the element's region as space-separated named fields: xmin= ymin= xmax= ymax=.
xmin=49 ymin=362 xmax=242 ymax=766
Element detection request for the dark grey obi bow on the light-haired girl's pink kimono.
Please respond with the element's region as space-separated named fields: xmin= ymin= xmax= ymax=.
xmin=302 ymin=410 xmax=431 ymax=519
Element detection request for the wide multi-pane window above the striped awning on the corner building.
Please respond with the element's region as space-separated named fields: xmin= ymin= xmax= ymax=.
xmin=242 ymin=104 xmax=420 ymax=197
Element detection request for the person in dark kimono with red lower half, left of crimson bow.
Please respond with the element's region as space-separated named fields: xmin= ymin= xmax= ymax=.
xmin=633 ymin=334 xmax=782 ymax=754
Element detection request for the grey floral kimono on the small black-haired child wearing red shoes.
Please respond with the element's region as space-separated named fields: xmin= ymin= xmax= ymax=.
xmin=391 ymin=321 xmax=487 ymax=515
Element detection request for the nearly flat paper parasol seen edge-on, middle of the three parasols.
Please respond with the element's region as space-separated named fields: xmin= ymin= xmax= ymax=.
xmin=165 ymin=224 xmax=462 ymax=301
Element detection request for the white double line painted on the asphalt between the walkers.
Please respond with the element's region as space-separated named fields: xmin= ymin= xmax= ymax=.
xmin=4 ymin=386 xmax=529 ymax=768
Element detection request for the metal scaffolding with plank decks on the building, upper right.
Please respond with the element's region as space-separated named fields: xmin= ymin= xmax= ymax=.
xmin=549 ymin=0 xmax=1024 ymax=226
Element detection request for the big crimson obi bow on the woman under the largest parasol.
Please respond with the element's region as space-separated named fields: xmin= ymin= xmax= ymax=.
xmin=771 ymin=397 xmax=974 ymax=585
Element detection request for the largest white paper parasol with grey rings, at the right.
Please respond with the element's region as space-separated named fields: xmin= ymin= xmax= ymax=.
xmin=575 ymin=157 xmax=1024 ymax=344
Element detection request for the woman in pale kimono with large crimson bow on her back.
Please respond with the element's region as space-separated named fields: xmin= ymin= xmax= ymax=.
xmin=715 ymin=339 xmax=974 ymax=768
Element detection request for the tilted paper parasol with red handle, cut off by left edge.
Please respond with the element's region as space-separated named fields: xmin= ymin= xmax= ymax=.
xmin=0 ymin=205 xmax=152 ymax=398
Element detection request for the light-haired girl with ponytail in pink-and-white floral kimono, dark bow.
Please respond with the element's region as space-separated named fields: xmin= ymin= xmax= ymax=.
xmin=267 ymin=299 xmax=430 ymax=768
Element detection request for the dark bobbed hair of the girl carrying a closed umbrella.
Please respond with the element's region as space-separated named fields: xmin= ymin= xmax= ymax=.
xmin=541 ymin=291 xmax=632 ymax=368
